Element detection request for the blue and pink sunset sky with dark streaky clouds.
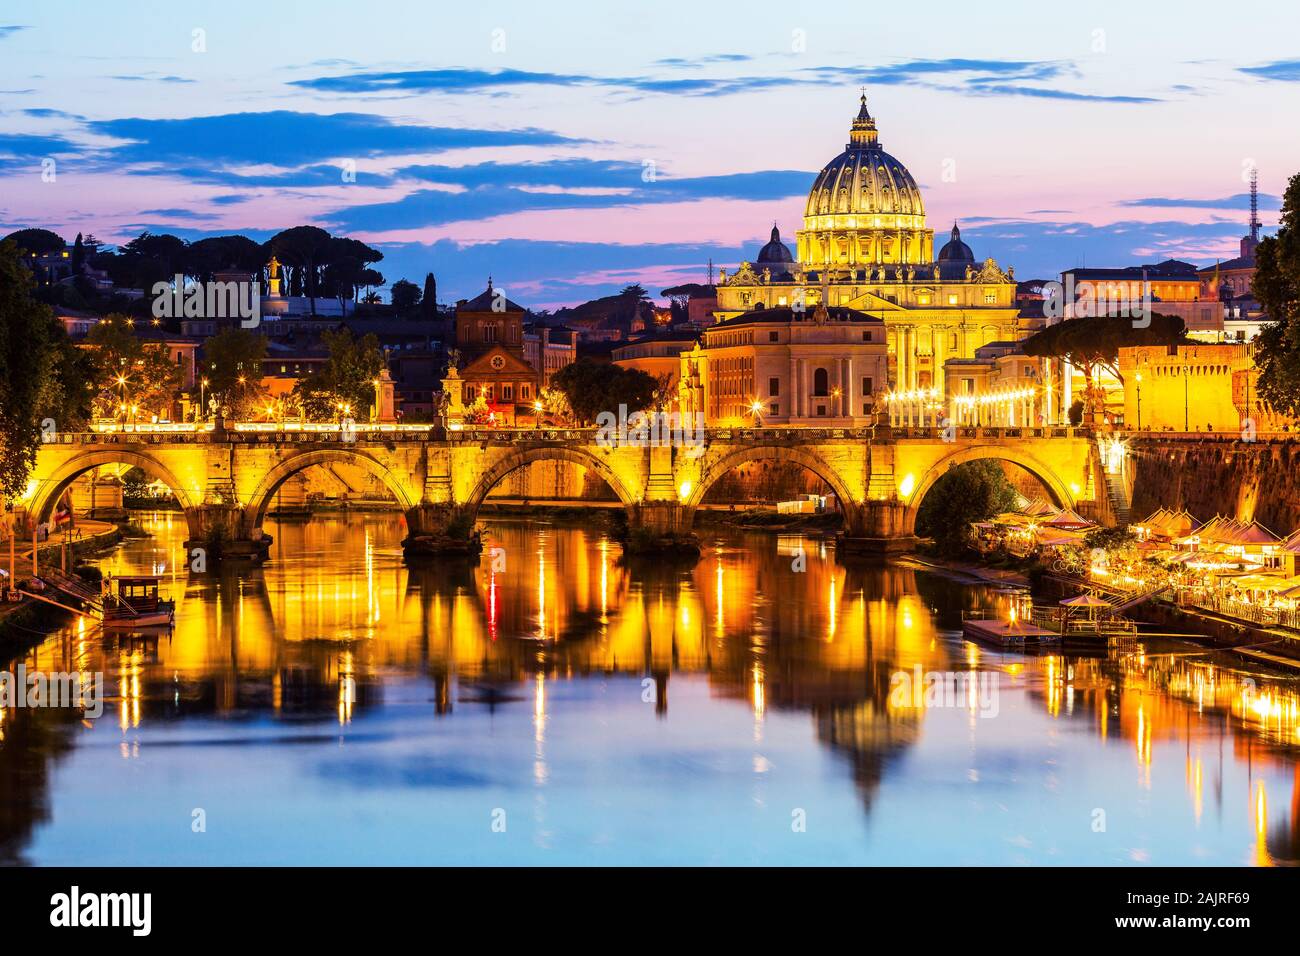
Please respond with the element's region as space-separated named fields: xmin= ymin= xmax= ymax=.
xmin=0 ymin=0 xmax=1300 ymax=308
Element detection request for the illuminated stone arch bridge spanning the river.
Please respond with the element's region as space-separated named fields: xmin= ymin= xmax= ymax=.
xmin=22 ymin=425 xmax=1106 ymax=557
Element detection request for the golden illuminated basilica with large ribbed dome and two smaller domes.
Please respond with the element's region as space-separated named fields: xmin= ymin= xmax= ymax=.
xmin=715 ymin=96 xmax=1027 ymax=392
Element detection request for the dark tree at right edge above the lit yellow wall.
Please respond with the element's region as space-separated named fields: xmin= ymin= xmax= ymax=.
xmin=1252 ymin=173 xmax=1300 ymax=416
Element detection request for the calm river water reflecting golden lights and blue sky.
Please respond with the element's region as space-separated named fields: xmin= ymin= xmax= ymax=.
xmin=0 ymin=514 xmax=1300 ymax=865
